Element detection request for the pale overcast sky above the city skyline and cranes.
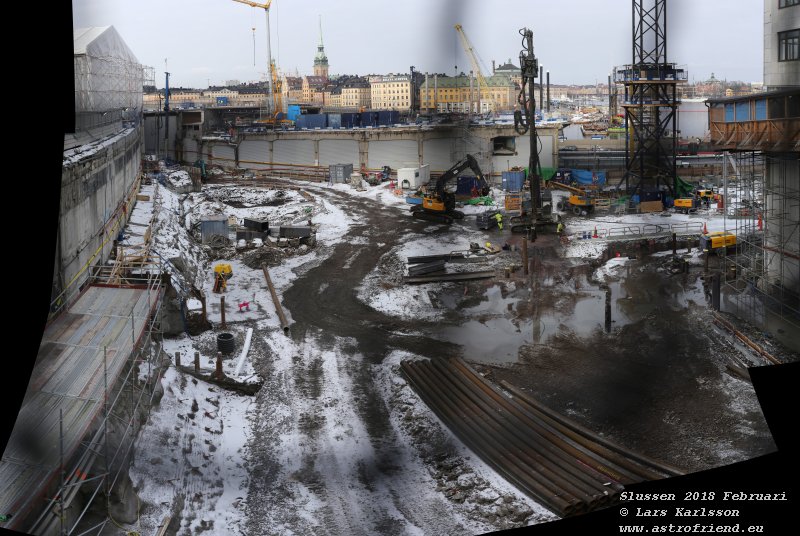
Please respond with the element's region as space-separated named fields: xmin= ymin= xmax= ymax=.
xmin=73 ymin=0 xmax=764 ymax=88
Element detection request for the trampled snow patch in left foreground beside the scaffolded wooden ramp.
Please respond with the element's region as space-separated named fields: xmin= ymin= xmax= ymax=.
xmin=130 ymin=337 xmax=253 ymax=534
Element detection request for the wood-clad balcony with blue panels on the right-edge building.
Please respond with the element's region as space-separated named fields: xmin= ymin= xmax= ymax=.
xmin=706 ymin=89 xmax=800 ymax=152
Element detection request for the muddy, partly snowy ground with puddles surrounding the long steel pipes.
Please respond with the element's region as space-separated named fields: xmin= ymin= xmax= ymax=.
xmin=131 ymin=181 xmax=792 ymax=535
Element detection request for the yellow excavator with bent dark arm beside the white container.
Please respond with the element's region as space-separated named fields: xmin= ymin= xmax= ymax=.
xmin=411 ymin=154 xmax=489 ymax=225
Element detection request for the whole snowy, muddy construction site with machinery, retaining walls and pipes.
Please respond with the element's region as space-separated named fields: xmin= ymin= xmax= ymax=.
xmin=0 ymin=0 xmax=800 ymax=536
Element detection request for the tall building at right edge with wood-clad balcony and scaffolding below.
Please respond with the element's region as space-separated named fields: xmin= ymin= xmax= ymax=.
xmin=707 ymin=0 xmax=800 ymax=350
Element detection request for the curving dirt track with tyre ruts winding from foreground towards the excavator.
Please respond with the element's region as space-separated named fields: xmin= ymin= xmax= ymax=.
xmin=248 ymin=186 xmax=488 ymax=535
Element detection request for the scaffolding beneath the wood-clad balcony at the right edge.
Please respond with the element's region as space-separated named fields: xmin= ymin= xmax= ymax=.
xmin=723 ymin=150 xmax=800 ymax=338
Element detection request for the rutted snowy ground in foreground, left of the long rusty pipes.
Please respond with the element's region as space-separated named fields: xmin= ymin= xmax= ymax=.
xmin=246 ymin=331 xmax=551 ymax=535
